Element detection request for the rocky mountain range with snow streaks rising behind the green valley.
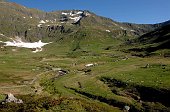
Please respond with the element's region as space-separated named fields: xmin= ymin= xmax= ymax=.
xmin=0 ymin=0 xmax=170 ymax=55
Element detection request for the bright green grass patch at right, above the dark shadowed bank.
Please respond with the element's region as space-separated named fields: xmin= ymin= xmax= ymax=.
xmin=97 ymin=59 xmax=170 ymax=89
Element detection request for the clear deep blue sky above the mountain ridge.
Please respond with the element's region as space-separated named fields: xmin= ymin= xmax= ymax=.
xmin=8 ymin=0 xmax=170 ymax=24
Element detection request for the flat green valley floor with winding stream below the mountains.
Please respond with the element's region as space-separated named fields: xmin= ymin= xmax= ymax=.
xmin=0 ymin=43 xmax=170 ymax=112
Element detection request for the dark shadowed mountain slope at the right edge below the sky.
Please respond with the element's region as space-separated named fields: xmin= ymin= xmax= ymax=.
xmin=125 ymin=21 xmax=170 ymax=57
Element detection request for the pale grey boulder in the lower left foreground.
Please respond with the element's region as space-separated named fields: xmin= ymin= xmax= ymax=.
xmin=4 ymin=93 xmax=23 ymax=103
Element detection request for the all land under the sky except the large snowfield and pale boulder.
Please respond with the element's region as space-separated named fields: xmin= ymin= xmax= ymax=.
xmin=0 ymin=0 xmax=170 ymax=112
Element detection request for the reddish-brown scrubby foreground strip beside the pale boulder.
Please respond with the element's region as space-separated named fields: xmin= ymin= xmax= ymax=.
xmin=0 ymin=95 xmax=120 ymax=112
